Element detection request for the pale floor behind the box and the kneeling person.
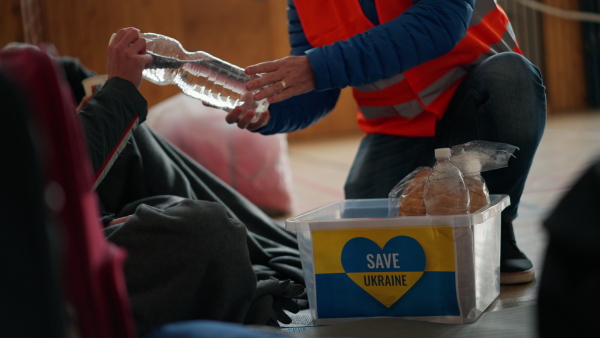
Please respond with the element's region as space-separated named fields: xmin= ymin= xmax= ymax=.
xmin=289 ymin=112 xmax=600 ymax=311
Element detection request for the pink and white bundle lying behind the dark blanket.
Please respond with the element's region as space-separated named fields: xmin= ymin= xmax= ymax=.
xmin=146 ymin=93 xmax=293 ymax=217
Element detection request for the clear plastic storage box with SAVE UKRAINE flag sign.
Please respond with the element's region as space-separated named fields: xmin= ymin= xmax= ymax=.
xmin=285 ymin=195 xmax=510 ymax=325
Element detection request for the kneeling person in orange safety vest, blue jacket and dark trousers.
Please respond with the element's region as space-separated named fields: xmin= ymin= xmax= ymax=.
xmin=226 ymin=0 xmax=546 ymax=284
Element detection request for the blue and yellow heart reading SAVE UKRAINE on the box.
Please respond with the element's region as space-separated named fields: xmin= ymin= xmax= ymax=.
xmin=341 ymin=236 xmax=425 ymax=308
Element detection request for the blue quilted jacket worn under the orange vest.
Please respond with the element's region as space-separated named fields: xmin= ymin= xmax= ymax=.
xmin=258 ymin=0 xmax=475 ymax=135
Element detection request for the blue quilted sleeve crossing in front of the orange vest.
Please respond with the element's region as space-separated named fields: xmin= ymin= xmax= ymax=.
xmin=306 ymin=0 xmax=475 ymax=90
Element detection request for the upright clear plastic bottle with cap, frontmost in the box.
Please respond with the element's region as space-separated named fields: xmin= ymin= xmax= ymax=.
xmin=423 ymin=148 xmax=469 ymax=215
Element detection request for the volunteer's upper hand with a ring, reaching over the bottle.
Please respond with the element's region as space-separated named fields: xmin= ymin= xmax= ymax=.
xmin=246 ymin=56 xmax=316 ymax=103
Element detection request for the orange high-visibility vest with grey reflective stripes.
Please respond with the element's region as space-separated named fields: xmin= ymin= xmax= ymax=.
xmin=294 ymin=0 xmax=522 ymax=136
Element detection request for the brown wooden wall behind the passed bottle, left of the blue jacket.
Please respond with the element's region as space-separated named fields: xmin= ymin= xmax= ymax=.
xmin=33 ymin=0 xmax=287 ymax=105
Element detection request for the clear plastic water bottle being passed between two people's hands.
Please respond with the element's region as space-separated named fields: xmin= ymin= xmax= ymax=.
xmin=141 ymin=33 xmax=269 ymax=115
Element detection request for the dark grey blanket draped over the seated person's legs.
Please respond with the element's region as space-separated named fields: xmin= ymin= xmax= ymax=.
xmin=97 ymin=125 xmax=305 ymax=333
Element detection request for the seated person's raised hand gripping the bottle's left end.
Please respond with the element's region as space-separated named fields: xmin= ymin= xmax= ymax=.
xmin=106 ymin=27 xmax=152 ymax=87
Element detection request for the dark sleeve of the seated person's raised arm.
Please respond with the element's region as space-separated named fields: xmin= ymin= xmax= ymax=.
xmin=79 ymin=77 xmax=148 ymax=189
